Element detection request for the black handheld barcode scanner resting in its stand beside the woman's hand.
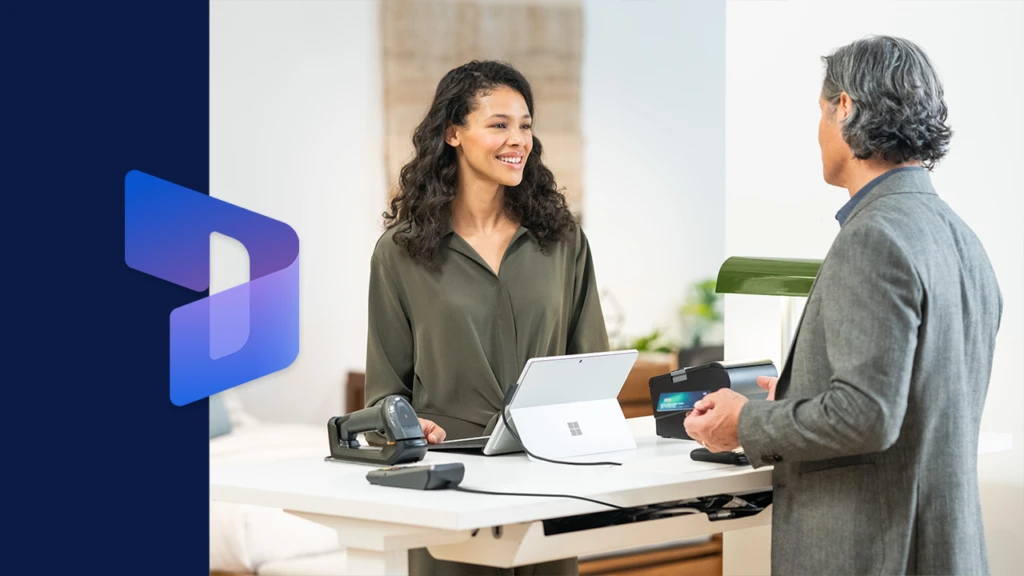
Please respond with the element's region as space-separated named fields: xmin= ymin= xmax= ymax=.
xmin=325 ymin=396 xmax=427 ymax=465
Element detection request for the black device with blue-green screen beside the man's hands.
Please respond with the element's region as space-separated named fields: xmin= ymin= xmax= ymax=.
xmin=648 ymin=360 xmax=778 ymax=440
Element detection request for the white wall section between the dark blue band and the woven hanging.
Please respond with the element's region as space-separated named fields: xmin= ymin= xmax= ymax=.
xmin=210 ymin=0 xmax=386 ymax=424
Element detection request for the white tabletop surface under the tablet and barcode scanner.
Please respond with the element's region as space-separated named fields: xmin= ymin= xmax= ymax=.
xmin=210 ymin=416 xmax=1011 ymax=530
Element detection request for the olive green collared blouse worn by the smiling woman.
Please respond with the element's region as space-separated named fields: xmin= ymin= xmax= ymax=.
xmin=366 ymin=217 xmax=608 ymax=440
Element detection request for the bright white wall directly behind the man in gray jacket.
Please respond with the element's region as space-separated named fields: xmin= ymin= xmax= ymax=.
xmin=725 ymin=0 xmax=1024 ymax=574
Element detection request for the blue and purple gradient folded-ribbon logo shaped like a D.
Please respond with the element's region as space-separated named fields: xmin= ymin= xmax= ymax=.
xmin=125 ymin=170 xmax=299 ymax=406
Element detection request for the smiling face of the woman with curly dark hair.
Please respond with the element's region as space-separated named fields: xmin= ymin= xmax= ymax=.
xmin=445 ymin=86 xmax=534 ymax=187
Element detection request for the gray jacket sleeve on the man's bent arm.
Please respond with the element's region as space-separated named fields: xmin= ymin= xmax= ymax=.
xmin=739 ymin=220 xmax=923 ymax=466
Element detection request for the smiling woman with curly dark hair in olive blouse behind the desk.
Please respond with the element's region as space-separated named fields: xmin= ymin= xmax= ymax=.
xmin=366 ymin=61 xmax=608 ymax=575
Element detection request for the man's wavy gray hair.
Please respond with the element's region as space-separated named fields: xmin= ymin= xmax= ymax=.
xmin=821 ymin=36 xmax=952 ymax=170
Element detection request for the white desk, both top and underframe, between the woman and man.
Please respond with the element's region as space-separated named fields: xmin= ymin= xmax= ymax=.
xmin=210 ymin=416 xmax=771 ymax=574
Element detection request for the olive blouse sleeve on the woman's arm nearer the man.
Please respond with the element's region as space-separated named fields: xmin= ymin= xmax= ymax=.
xmin=566 ymin=228 xmax=609 ymax=354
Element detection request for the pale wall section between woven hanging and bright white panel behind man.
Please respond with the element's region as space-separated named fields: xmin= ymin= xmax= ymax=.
xmin=582 ymin=0 xmax=725 ymax=344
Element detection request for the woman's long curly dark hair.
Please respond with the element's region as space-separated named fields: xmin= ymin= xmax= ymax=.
xmin=384 ymin=60 xmax=575 ymax=265
